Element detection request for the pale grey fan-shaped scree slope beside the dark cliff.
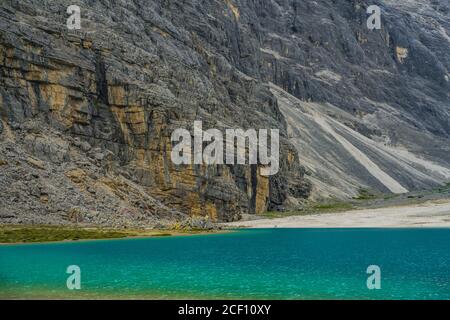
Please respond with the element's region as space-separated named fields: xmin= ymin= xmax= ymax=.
xmin=272 ymin=81 xmax=450 ymax=199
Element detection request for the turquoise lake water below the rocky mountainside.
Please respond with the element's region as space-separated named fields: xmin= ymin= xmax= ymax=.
xmin=0 ymin=229 xmax=450 ymax=299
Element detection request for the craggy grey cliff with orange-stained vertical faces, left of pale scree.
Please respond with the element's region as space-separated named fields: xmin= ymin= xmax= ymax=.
xmin=0 ymin=1 xmax=310 ymax=221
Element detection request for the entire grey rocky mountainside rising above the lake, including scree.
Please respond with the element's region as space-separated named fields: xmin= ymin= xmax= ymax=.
xmin=0 ymin=0 xmax=450 ymax=226
